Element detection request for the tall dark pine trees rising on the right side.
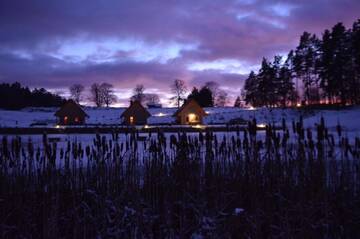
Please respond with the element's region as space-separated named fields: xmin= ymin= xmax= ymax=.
xmin=242 ymin=19 xmax=360 ymax=107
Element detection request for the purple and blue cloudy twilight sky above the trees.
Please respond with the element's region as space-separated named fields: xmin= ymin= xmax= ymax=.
xmin=0 ymin=0 xmax=360 ymax=105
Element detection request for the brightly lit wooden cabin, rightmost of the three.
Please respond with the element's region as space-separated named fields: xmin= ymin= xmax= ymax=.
xmin=174 ymin=99 xmax=206 ymax=125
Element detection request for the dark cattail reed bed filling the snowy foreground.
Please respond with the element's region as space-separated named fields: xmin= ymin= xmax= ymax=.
xmin=0 ymin=119 xmax=360 ymax=238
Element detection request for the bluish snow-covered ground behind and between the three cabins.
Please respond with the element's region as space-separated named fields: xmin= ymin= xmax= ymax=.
xmin=0 ymin=107 xmax=360 ymax=134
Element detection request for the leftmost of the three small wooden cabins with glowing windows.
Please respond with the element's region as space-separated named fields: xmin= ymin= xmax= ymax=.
xmin=55 ymin=100 xmax=89 ymax=125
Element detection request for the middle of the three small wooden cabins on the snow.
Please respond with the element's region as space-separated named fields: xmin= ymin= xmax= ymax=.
xmin=121 ymin=101 xmax=151 ymax=125
